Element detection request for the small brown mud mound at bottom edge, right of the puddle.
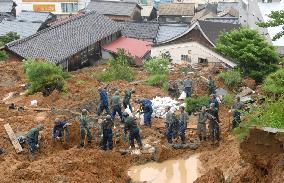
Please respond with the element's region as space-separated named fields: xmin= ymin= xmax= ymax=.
xmin=194 ymin=168 xmax=225 ymax=183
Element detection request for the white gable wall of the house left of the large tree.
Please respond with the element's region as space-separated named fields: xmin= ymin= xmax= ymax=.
xmin=151 ymin=42 xmax=235 ymax=67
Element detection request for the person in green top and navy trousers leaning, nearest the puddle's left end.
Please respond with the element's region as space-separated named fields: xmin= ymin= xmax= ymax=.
xmin=123 ymin=112 xmax=142 ymax=149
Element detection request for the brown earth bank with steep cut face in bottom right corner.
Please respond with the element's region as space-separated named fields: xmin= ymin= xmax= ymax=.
xmin=237 ymin=128 xmax=284 ymax=182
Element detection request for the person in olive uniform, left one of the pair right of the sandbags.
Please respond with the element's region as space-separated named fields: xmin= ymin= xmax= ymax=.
xmin=197 ymin=106 xmax=207 ymax=141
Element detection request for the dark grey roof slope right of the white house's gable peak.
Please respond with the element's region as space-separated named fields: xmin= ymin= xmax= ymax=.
xmin=198 ymin=21 xmax=240 ymax=44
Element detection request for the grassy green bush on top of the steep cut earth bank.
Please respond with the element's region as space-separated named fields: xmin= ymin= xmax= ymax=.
xmin=234 ymin=98 xmax=284 ymax=140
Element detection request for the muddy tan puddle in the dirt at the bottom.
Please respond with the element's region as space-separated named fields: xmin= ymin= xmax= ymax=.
xmin=128 ymin=154 xmax=201 ymax=183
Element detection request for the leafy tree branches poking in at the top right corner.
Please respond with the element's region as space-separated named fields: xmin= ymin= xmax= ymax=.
xmin=257 ymin=10 xmax=284 ymax=41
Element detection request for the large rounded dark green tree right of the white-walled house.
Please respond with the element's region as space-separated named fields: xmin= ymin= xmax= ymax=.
xmin=216 ymin=27 xmax=280 ymax=83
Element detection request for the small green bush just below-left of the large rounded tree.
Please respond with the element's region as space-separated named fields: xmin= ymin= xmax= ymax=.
xmin=218 ymin=70 xmax=242 ymax=89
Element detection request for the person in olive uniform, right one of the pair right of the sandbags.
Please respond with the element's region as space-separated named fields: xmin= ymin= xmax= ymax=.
xmin=206 ymin=103 xmax=220 ymax=143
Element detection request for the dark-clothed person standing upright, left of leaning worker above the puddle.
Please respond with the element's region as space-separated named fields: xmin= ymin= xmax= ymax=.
xmin=101 ymin=115 xmax=114 ymax=150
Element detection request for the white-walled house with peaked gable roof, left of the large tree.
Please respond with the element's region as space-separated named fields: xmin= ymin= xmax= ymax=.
xmin=151 ymin=21 xmax=240 ymax=67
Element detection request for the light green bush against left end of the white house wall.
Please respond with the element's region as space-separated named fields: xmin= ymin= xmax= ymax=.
xmin=144 ymin=56 xmax=170 ymax=74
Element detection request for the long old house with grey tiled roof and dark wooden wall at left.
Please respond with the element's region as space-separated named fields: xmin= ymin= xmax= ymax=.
xmin=5 ymin=12 xmax=121 ymax=71
